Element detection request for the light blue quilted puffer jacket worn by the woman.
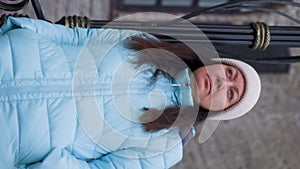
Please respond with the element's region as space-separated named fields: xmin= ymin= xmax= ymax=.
xmin=0 ymin=17 xmax=193 ymax=169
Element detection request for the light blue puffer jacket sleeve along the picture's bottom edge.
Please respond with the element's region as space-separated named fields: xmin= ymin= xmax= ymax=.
xmin=25 ymin=141 xmax=182 ymax=169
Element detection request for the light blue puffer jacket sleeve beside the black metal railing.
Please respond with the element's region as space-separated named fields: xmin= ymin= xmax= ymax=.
xmin=0 ymin=17 xmax=143 ymax=46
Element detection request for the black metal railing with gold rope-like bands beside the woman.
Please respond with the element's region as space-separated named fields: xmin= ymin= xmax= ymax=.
xmin=0 ymin=0 xmax=300 ymax=64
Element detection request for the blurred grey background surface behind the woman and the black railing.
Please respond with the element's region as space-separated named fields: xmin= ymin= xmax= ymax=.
xmin=2 ymin=0 xmax=300 ymax=169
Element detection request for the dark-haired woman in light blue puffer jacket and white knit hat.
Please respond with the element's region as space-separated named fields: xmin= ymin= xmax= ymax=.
xmin=0 ymin=18 xmax=260 ymax=169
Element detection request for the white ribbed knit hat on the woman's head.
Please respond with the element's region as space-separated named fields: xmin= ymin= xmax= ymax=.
xmin=207 ymin=58 xmax=261 ymax=120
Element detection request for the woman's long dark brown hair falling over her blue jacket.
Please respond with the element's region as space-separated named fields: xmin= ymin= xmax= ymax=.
xmin=126 ymin=35 xmax=208 ymax=132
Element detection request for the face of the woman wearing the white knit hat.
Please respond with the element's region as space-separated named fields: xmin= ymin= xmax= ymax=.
xmin=193 ymin=64 xmax=245 ymax=110
